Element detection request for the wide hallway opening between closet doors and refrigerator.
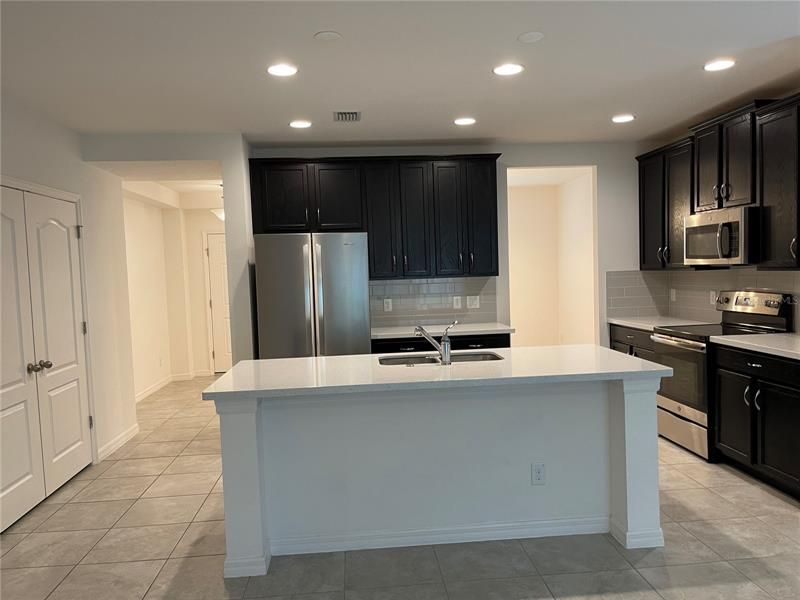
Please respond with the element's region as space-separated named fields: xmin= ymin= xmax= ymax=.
xmin=96 ymin=161 xmax=231 ymax=402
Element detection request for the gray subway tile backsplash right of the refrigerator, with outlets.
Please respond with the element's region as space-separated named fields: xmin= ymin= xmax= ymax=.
xmin=369 ymin=277 xmax=497 ymax=327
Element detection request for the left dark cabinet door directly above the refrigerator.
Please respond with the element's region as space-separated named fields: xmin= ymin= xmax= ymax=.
xmin=260 ymin=164 xmax=311 ymax=233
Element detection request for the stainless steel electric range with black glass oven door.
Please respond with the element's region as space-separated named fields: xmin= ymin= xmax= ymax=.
xmin=650 ymin=290 xmax=793 ymax=459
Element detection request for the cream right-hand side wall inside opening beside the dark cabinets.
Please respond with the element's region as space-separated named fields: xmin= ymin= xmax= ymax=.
xmin=557 ymin=169 xmax=605 ymax=344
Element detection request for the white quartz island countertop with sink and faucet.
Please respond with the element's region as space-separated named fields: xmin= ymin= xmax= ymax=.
xmin=203 ymin=345 xmax=672 ymax=400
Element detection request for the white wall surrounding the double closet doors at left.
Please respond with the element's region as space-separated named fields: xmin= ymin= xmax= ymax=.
xmin=0 ymin=93 xmax=138 ymax=457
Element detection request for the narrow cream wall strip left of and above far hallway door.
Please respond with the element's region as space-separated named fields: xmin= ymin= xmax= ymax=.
xmin=183 ymin=209 xmax=225 ymax=375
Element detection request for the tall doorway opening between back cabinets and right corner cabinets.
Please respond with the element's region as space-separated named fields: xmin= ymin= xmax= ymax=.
xmin=508 ymin=166 xmax=599 ymax=346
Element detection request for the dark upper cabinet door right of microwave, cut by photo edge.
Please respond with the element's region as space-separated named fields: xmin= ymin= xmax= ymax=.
xmin=756 ymin=106 xmax=800 ymax=267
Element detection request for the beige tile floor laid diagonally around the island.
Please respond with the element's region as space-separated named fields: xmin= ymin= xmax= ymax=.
xmin=0 ymin=378 xmax=800 ymax=600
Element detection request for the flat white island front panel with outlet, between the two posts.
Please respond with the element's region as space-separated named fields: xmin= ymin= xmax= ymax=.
xmin=256 ymin=381 xmax=610 ymax=555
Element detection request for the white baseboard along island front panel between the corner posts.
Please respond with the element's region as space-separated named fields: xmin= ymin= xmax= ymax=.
xmin=272 ymin=517 xmax=608 ymax=556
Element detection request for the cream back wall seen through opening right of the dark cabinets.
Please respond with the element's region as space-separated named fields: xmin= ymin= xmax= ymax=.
xmin=508 ymin=186 xmax=559 ymax=346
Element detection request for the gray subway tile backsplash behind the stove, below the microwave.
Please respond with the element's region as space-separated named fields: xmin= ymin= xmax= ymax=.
xmin=606 ymin=267 xmax=800 ymax=329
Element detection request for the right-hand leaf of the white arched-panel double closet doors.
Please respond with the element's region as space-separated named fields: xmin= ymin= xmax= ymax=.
xmin=25 ymin=192 xmax=92 ymax=494
